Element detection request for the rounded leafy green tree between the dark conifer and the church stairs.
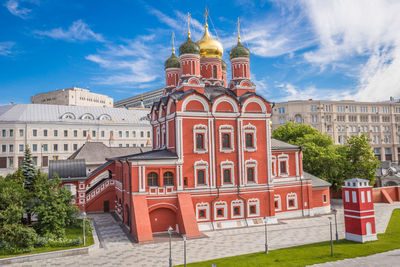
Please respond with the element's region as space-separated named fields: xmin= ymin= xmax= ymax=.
xmin=34 ymin=174 xmax=78 ymax=238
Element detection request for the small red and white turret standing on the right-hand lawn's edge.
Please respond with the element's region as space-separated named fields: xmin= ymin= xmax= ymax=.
xmin=342 ymin=178 xmax=377 ymax=243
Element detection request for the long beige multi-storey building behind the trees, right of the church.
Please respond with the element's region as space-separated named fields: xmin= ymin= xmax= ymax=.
xmin=272 ymin=99 xmax=400 ymax=162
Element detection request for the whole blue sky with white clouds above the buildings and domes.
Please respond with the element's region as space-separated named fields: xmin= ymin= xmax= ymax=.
xmin=0 ymin=0 xmax=400 ymax=104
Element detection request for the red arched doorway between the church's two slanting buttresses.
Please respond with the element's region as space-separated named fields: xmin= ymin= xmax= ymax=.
xmin=150 ymin=208 xmax=176 ymax=233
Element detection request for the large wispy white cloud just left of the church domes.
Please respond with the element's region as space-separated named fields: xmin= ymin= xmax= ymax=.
xmin=86 ymin=34 xmax=168 ymax=88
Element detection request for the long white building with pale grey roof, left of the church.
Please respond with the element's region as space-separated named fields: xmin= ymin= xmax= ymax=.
xmin=0 ymin=104 xmax=152 ymax=178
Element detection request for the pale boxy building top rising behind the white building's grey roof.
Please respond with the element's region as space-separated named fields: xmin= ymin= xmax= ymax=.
xmin=31 ymin=87 xmax=114 ymax=108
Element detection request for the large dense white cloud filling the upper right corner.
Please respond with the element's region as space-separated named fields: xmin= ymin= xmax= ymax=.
xmin=303 ymin=0 xmax=400 ymax=101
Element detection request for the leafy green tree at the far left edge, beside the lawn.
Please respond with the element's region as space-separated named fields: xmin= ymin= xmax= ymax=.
xmin=0 ymin=179 xmax=37 ymax=252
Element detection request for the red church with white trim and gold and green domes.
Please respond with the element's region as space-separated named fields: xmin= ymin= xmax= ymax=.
xmin=59 ymin=12 xmax=330 ymax=242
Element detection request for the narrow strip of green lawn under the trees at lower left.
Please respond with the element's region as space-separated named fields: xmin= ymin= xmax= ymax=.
xmin=0 ymin=220 xmax=94 ymax=258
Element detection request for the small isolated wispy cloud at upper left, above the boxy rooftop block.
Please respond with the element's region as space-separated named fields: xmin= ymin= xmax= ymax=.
xmin=34 ymin=20 xmax=104 ymax=42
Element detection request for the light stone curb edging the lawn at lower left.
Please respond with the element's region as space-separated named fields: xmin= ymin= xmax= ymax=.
xmin=0 ymin=222 xmax=99 ymax=266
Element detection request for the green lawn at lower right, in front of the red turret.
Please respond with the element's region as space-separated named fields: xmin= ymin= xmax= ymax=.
xmin=180 ymin=209 xmax=400 ymax=267
